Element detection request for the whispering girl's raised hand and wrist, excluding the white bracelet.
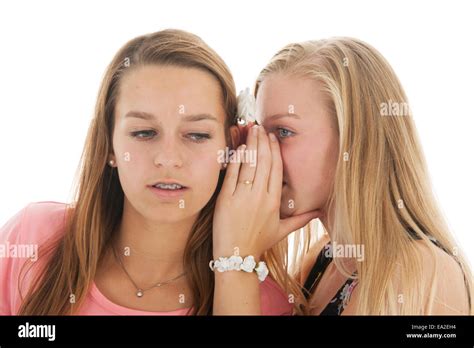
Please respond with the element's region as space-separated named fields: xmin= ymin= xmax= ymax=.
xmin=212 ymin=124 xmax=322 ymax=315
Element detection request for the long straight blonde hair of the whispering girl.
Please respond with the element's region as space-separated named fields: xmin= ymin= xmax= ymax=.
xmin=255 ymin=38 xmax=473 ymax=314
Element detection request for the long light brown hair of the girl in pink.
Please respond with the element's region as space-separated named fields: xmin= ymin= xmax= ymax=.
xmin=19 ymin=29 xmax=241 ymax=315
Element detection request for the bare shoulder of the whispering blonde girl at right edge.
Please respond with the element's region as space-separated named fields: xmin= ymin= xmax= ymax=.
xmin=416 ymin=241 xmax=469 ymax=315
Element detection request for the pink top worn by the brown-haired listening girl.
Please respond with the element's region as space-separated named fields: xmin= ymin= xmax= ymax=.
xmin=0 ymin=202 xmax=292 ymax=315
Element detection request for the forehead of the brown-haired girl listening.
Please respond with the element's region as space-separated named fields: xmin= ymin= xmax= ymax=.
xmin=117 ymin=65 xmax=223 ymax=117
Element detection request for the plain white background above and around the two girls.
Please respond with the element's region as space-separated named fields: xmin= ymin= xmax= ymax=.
xmin=0 ymin=0 xmax=474 ymax=264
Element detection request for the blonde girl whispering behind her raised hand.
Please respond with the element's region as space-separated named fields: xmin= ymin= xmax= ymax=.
xmin=214 ymin=38 xmax=473 ymax=315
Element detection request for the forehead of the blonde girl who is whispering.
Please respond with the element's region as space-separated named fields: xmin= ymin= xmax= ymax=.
xmin=257 ymin=74 xmax=328 ymax=123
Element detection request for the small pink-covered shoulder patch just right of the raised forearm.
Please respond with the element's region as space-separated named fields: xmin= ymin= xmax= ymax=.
xmin=260 ymin=276 xmax=293 ymax=315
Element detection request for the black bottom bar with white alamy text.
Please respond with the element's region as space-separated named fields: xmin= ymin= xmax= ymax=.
xmin=0 ymin=316 xmax=474 ymax=348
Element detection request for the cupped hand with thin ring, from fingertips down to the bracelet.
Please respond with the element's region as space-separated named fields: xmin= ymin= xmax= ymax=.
xmin=213 ymin=125 xmax=322 ymax=258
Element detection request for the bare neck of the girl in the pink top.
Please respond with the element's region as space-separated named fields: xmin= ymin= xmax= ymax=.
xmin=112 ymin=198 xmax=195 ymax=284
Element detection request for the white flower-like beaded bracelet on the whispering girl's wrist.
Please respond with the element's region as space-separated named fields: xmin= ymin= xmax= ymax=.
xmin=209 ymin=255 xmax=268 ymax=282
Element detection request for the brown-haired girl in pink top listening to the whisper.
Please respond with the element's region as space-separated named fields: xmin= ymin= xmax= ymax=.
xmin=0 ymin=30 xmax=291 ymax=315
